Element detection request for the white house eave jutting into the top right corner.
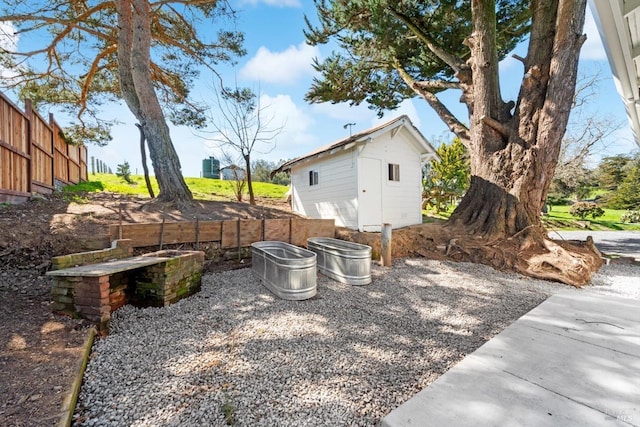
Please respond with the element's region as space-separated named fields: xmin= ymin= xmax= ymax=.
xmin=589 ymin=0 xmax=640 ymax=145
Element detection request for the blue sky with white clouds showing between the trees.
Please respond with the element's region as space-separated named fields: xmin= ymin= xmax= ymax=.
xmin=5 ymin=0 xmax=637 ymax=177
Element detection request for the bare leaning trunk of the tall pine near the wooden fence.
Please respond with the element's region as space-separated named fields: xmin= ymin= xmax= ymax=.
xmin=117 ymin=0 xmax=193 ymax=204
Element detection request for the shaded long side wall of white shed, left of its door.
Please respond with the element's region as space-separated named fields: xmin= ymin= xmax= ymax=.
xmin=291 ymin=150 xmax=358 ymax=228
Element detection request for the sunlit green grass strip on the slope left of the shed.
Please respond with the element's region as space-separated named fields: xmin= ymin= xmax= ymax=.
xmin=65 ymin=173 xmax=288 ymax=201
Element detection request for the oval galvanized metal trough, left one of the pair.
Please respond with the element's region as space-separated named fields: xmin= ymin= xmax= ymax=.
xmin=251 ymin=241 xmax=317 ymax=300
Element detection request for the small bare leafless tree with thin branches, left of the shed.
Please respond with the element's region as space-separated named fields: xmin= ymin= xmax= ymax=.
xmin=204 ymin=86 xmax=282 ymax=205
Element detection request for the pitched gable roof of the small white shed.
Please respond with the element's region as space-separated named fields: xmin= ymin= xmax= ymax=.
xmin=271 ymin=115 xmax=435 ymax=175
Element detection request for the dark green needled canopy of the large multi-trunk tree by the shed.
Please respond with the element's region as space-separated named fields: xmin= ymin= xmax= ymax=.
xmin=305 ymin=0 xmax=531 ymax=141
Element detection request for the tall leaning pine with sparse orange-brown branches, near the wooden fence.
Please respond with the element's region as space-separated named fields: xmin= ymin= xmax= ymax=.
xmin=0 ymin=0 xmax=244 ymax=203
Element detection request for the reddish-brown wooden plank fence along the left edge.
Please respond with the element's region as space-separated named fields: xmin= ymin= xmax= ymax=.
xmin=0 ymin=93 xmax=87 ymax=202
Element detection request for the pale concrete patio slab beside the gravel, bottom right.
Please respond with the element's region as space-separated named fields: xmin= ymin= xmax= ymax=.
xmin=382 ymin=290 xmax=640 ymax=427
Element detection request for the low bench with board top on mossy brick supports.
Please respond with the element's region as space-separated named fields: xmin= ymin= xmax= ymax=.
xmin=46 ymin=244 xmax=204 ymax=334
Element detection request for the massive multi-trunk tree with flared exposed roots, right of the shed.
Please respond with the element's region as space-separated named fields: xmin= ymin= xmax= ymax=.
xmin=307 ymin=0 xmax=602 ymax=286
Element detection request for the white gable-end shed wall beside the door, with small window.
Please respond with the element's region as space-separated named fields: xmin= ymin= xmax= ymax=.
xmin=358 ymin=128 xmax=422 ymax=228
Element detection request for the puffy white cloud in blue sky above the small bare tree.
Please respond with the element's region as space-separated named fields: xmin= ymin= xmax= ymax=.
xmin=240 ymin=42 xmax=319 ymax=85
